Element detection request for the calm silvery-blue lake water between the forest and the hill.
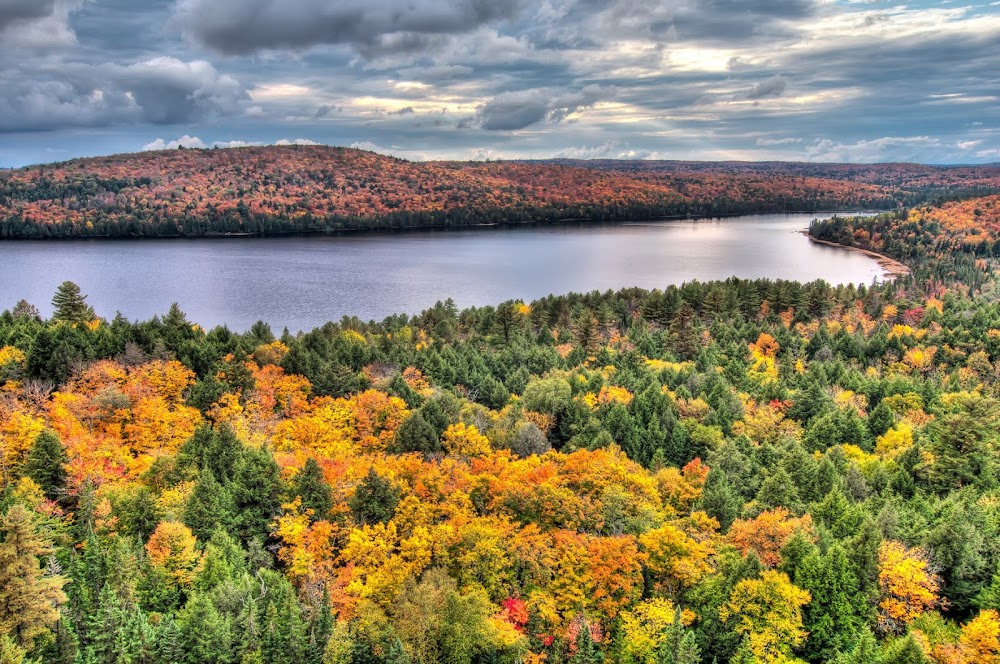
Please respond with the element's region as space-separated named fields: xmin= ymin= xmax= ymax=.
xmin=0 ymin=214 xmax=883 ymax=332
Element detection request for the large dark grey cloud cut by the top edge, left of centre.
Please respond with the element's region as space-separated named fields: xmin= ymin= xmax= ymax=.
xmin=175 ymin=0 xmax=521 ymax=55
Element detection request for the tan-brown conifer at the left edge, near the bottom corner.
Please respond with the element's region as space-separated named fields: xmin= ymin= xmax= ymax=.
xmin=0 ymin=504 xmax=66 ymax=651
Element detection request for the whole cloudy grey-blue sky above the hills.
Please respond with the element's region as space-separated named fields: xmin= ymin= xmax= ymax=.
xmin=0 ymin=0 xmax=1000 ymax=167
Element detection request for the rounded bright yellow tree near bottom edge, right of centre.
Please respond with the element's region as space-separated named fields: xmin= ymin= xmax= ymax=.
xmin=719 ymin=570 xmax=812 ymax=662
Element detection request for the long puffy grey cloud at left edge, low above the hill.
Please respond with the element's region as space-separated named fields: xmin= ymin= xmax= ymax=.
xmin=0 ymin=57 xmax=249 ymax=131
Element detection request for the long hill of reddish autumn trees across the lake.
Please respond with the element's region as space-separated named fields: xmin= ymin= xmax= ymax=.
xmin=0 ymin=146 xmax=1000 ymax=238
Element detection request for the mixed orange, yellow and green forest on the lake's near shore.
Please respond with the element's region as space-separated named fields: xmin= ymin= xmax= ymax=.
xmin=0 ymin=193 xmax=1000 ymax=664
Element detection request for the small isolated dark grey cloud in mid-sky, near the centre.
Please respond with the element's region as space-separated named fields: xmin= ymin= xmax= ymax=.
xmin=476 ymin=85 xmax=614 ymax=131
